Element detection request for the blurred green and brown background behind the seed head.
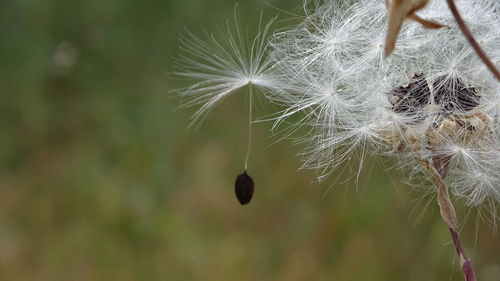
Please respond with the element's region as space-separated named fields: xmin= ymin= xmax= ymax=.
xmin=0 ymin=0 xmax=500 ymax=281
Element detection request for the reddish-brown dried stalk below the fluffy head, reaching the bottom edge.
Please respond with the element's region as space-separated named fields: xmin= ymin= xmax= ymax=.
xmin=417 ymin=158 xmax=476 ymax=281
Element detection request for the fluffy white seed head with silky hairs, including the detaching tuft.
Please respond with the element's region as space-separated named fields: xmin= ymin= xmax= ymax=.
xmin=179 ymin=0 xmax=500 ymax=208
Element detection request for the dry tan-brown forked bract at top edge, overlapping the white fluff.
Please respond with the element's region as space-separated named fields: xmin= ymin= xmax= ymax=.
xmin=385 ymin=0 xmax=445 ymax=57
